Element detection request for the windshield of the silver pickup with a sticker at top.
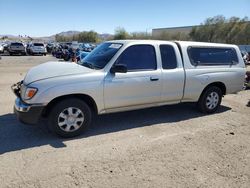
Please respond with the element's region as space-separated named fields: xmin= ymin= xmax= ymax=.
xmin=80 ymin=42 xmax=122 ymax=69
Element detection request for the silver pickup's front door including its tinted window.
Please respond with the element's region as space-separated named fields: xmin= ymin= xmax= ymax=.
xmin=104 ymin=45 xmax=161 ymax=110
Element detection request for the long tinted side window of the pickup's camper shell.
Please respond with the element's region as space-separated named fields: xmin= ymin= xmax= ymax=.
xmin=188 ymin=47 xmax=238 ymax=66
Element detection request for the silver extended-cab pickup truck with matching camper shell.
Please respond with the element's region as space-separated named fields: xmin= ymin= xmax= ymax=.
xmin=12 ymin=40 xmax=246 ymax=137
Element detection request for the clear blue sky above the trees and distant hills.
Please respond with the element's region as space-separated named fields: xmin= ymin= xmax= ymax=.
xmin=0 ymin=0 xmax=250 ymax=37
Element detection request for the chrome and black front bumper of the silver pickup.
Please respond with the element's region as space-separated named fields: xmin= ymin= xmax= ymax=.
xmin=14 ymin=98 xmax=45 ymax=124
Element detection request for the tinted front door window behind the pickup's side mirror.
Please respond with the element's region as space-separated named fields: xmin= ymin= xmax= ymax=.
xmin=116 ymin=45 xmax=157 ymax=71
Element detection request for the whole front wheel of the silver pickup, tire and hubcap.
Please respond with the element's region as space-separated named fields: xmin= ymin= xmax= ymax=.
xmin=48 ymin=98 xmax=92 ymax=138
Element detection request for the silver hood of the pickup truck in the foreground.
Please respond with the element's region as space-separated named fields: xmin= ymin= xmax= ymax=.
xmin=24 ymin=62 xmax=94 ymax=85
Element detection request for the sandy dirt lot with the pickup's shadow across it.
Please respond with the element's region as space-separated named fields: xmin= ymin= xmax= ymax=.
xmin=0 ymin=56 xmax=250 ymax=188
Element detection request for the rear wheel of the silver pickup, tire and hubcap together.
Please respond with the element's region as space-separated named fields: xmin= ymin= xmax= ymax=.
xmin=198 ymin=86 xmax=222 ymax=114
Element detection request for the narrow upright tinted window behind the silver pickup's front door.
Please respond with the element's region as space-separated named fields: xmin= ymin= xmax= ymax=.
xmin=160 ymin=44 xmax=177 ymax=69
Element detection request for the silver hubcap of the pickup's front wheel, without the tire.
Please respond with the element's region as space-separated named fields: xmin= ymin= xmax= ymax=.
xmin=58 ymin=107 xmax=84 ymax=132
